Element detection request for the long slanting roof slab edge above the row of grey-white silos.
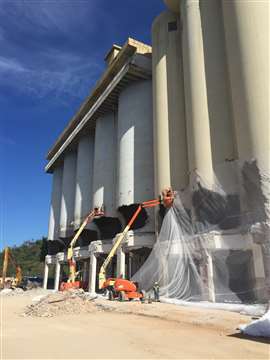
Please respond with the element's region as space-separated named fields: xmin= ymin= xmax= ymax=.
xmin=46 ymin=38 xmax=152 ymax=160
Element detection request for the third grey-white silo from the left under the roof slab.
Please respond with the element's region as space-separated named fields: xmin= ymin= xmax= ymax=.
xmin=74 ymin=133 xmax=94 ymax=228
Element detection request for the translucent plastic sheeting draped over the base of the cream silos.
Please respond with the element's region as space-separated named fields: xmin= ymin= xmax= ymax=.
xmin=132 ymin=160 xmax=270 ymax=303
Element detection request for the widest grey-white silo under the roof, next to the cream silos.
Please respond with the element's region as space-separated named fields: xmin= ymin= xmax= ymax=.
xmin=117 ymin=80 xmax=154 ymax=231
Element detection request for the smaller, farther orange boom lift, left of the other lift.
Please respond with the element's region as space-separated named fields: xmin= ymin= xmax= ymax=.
xmin=60 ymin=208 xmax=104 ymax=291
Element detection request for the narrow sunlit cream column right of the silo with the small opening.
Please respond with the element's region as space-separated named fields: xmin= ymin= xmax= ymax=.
xmin=181 ymin=0 xmax=213 ymax=187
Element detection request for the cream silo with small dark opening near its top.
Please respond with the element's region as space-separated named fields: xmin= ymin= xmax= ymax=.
xmin=152 ymin=11 xmax=188 ymax=194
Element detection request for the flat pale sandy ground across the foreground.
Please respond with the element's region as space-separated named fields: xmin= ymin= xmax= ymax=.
xmin=0 ymin=292 xmax=270 ymax=360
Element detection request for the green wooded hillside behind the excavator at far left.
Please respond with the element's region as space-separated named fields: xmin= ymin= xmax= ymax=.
xmin=0 ymin=238 xmax=47 ymax=276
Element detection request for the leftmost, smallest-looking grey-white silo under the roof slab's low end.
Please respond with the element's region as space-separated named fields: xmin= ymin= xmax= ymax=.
xmin=48 ymin=165 xmax=63 ymax=240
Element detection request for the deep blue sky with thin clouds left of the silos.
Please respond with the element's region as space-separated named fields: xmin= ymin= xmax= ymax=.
xmin=0 ymin=0 xmax=164 ymax=248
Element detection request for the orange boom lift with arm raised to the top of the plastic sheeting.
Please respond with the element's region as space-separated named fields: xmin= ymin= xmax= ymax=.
xmin=99 ymin=188 xmax=174 ymax=301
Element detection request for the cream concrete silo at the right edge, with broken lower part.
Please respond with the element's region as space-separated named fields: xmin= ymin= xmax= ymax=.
xmin=222 ymin=0 xmax=270 ymax=299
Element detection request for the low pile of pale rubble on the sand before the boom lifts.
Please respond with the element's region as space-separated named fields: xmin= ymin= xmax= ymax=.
xmin=22 ymin=289 xmax=98 ymax=317
